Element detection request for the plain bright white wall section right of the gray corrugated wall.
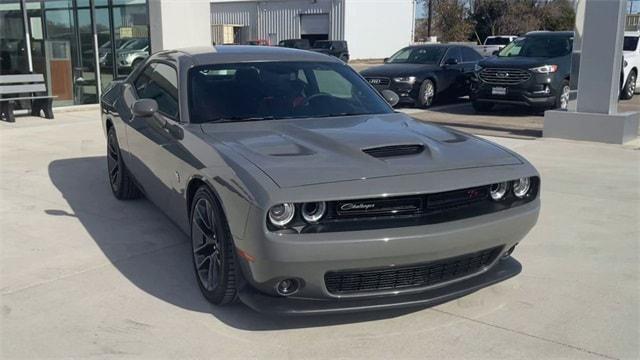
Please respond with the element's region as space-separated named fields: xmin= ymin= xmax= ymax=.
xmin=345 ymin=0 xmax=415 ymax=59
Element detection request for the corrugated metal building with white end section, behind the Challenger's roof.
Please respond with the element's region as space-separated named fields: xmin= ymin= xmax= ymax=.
xmin=211 ymin=0 xmax=416 ymax=59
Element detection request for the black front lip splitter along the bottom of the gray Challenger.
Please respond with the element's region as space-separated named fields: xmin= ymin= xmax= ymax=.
xmin=239 ymin=257 xmax=522 ymax=315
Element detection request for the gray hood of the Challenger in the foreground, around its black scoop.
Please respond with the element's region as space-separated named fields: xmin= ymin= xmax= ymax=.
xmin=202 ymin=113 xmax=522 ymax=188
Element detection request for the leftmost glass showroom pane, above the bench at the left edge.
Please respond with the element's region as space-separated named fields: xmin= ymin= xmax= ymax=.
xmin=0 ymin=0 xmax=29 ymax=74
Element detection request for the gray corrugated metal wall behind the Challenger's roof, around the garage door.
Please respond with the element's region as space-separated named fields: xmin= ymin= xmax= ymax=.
xmin=211 ymin=0 xmax=348 ymax=45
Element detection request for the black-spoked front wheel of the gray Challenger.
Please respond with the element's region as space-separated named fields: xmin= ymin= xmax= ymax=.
xmin=191 ymin=185 xmax=238 ymax=305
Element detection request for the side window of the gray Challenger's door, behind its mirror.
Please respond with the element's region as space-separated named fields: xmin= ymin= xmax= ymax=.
xmin=136 ymin=63 xmax=178 ymax=120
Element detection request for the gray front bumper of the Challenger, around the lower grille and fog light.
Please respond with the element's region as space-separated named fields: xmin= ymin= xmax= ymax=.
xmin=235 ymin=199 xmax=540 ymax=313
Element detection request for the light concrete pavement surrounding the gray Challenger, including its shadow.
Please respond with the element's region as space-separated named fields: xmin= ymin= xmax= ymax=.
xmin=0 ymin=110 xmax=640 ymax=359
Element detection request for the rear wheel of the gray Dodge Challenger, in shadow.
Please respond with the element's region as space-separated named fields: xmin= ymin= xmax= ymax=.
xmin=107 ymin=127 xmax=142 ymax=200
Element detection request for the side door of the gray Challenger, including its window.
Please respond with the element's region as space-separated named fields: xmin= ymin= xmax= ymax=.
xmin=122 ymin=62 xmax=184 ymax=212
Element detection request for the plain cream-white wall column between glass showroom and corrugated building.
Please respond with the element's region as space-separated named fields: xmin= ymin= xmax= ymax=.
xmin=149 ymin=0 xmax=212 ymax=52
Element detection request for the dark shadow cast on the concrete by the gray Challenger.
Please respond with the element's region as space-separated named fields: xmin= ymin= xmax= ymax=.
xmin=45 ymin=156 xmax=436 ymax=331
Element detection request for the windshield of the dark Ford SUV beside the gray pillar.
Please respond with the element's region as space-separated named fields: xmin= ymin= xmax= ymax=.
xmin=498 ymin=36 xmax=573 ymax=58
